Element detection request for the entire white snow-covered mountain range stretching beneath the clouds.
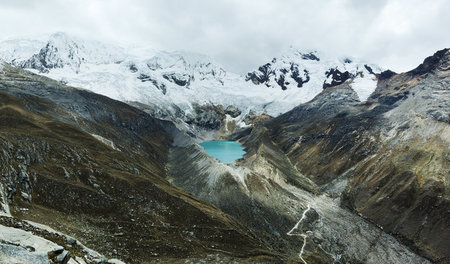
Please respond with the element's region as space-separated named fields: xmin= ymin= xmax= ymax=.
xmin=0 ymin=32 xmax=381 ymax=116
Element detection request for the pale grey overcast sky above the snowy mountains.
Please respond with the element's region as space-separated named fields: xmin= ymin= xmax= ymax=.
xmin=0 ymin=0 xmax=450 ymax=73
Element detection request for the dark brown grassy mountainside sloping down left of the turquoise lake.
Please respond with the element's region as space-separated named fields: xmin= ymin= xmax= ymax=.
xmin=0 ymin=64 xmax=279 ymax=263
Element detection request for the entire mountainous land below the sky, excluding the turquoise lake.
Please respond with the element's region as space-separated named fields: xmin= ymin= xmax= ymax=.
xmin=0 ymin=32 xmax=450 ymax=264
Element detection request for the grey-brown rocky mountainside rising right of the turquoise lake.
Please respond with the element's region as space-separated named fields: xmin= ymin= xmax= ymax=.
xmin=266 ymin=49 xmax=450 ymax=263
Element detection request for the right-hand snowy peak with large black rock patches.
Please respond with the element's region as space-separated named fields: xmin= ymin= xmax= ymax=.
xmin=246 ymin=47 xmax=382 ymax=101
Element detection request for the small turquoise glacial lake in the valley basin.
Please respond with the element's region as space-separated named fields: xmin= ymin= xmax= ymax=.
xmin=200 ymin=140 xmax=245 ymax=163
